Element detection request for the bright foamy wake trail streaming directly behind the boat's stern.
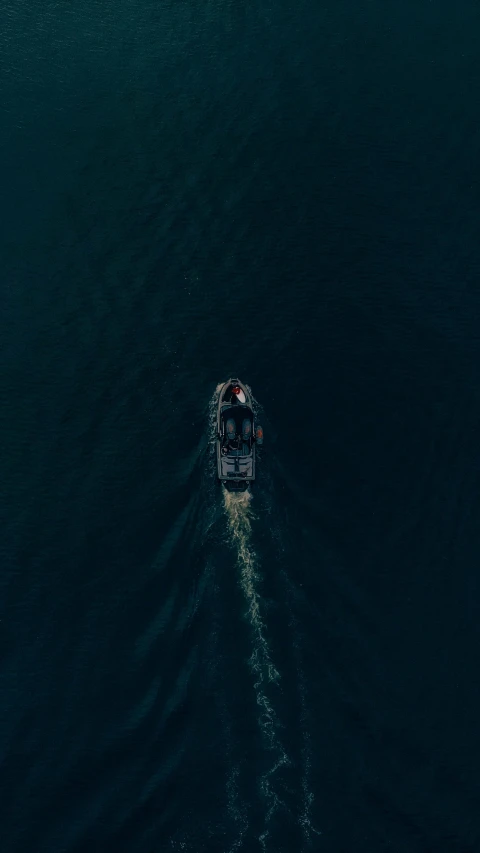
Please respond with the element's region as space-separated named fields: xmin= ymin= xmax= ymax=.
xmin=224 ymin=490 xmax=290 ymax=849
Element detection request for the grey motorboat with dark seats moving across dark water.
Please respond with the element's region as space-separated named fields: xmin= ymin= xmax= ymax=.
xmin=216 ymin=379 xmax=263 ymax=492
